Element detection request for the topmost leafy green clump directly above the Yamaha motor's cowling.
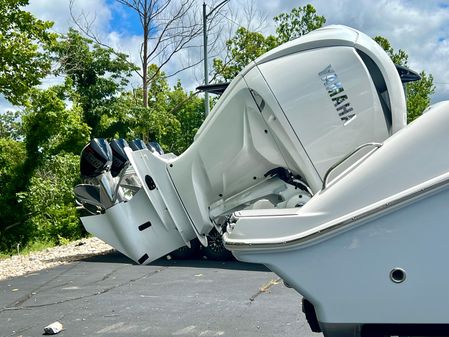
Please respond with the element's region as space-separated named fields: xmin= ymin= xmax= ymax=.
xmin=274 ymin=4 xmax=326 ymax=44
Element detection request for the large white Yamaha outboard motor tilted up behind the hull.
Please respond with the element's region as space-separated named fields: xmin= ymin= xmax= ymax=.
xmin=82 ymin=26 xmax=406 ymax=264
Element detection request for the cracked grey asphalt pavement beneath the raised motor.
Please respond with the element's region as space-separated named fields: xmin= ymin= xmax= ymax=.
xmin=0 ymin=253 xmax=322 ymax=337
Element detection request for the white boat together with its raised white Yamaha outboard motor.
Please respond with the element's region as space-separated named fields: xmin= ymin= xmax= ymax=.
xmin=76 ymin=26 xmax=449 ymax=337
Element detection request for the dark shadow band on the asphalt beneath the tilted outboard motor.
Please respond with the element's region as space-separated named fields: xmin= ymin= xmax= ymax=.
xmin=81 ymin=251 xmax=269 ymax=272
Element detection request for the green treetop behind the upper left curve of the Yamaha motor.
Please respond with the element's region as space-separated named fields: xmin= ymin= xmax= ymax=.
xmin=214 ymin=4 xmax=326 ymax=81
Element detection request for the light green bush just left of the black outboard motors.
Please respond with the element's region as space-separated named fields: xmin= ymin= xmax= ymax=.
xmin=18 ymin=152 xmax=82 ymax=244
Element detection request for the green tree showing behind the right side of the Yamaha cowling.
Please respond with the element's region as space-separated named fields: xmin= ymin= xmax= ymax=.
xmin=374 ymin=36 xmax=435 ymax=123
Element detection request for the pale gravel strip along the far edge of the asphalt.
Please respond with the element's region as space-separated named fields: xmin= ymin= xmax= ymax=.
xmin=0 ymin=238 xmax=114 ymax=280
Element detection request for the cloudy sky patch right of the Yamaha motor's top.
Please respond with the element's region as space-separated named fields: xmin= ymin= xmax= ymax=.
xmin=292 ymin=0 xmax=449 ymax=101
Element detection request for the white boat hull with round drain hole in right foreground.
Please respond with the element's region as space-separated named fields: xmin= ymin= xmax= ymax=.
xmin=224 ymin=102 xmax=449 ymax=336
